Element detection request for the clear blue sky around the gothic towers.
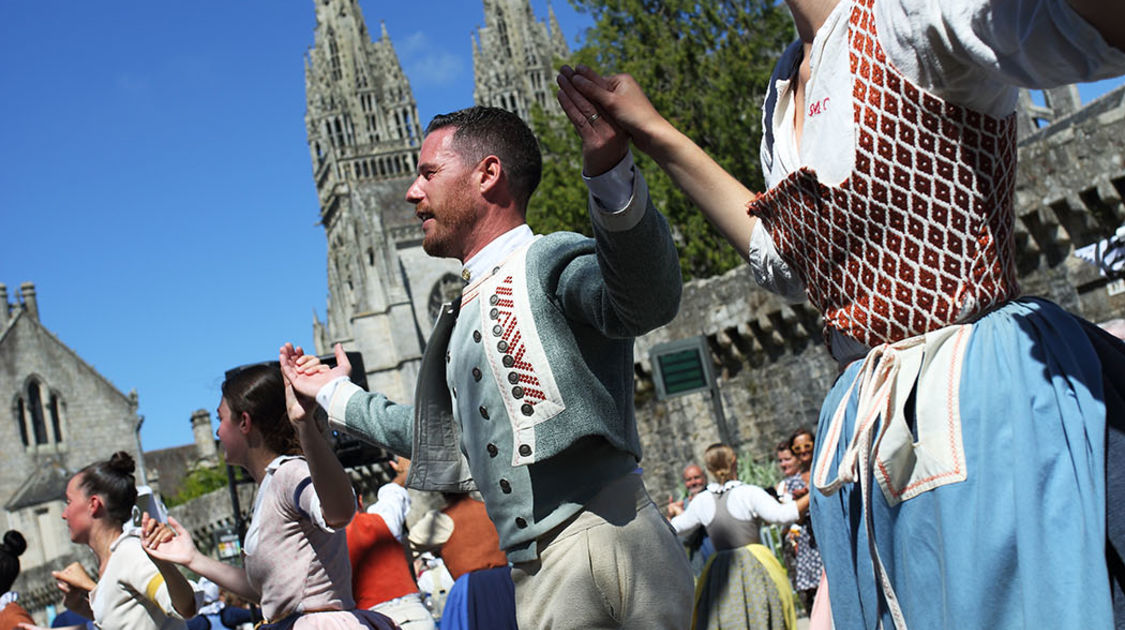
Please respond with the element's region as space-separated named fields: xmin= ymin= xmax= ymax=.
xmin=0 ymin=0 xmax=1118 ymax=450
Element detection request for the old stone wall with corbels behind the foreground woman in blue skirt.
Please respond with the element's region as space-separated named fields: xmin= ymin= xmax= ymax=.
xmin=635 ymin=88 xmax=1125 ymax=503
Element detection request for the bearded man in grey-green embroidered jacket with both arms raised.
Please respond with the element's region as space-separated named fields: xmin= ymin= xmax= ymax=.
xmin=281 ymin=105 xmax=692 ymax=629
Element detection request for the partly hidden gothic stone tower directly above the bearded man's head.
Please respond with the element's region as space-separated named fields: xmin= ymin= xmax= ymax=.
xmin=473 ymin=0 xmax=570 ymax=122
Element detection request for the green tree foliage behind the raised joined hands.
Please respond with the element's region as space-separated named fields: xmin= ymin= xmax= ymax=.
xmin=528 ymin=0 xmax=794 ymax=278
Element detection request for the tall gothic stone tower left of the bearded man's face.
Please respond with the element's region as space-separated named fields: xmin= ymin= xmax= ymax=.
xmin=305 ymin=0 xmax=460 ymax=402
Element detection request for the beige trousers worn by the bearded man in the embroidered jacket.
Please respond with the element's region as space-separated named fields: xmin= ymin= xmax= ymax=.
xmin=512 ymin=474 xmax=693 ymax=630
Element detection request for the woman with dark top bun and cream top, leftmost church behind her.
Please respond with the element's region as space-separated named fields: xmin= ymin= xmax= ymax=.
xmin=21 ymin=451 xmax=198 ymax=630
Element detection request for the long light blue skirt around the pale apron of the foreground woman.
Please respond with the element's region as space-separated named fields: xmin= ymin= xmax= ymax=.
xmin=812 ymin=299 xmax=1113 ymax=630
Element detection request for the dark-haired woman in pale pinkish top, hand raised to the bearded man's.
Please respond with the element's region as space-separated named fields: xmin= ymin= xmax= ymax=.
xmin=143 ymin=357 xmax=395 ymax=630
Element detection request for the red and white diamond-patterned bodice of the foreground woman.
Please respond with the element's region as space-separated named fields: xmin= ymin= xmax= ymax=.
xmin=748 ymin=0 xmax=1019 ymax=347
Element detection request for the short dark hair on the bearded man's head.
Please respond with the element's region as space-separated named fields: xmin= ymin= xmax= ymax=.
xmin=425 ymin=106 xmax=543 ymax=210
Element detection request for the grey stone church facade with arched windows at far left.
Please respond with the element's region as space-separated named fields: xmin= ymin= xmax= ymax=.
xmin=0 ymin=282 xmax=144 ymax=621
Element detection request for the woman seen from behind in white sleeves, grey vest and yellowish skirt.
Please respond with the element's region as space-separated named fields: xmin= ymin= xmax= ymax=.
xmin=671 ymin=444 xmax=809 ymax=630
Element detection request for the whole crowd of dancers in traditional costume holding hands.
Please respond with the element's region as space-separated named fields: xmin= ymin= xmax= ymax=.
xmin=3 ymin=0 xmax=1125 ymax=629
